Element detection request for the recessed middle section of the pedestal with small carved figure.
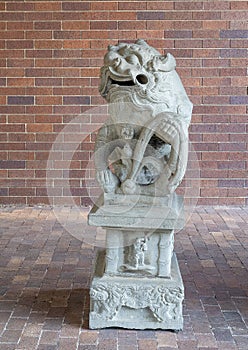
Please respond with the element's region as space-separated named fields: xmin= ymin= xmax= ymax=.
xmin=105 ymin=228 xmax=174 ymax=278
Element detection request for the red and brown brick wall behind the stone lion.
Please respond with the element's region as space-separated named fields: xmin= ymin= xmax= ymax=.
xmin=0 ymin=0 xmax=248 ymax=204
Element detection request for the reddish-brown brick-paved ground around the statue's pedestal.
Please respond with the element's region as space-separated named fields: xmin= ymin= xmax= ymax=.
xmin=0 ymin=207 xmax=248 ymax=350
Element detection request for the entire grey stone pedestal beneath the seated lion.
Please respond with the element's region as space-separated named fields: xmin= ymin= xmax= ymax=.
xmin=88 ymin=194 xmax=184 ymax=330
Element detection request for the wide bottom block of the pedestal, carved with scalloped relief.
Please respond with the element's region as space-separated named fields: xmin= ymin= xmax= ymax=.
xmin=89 ymin=253 xmax=184 ymax=331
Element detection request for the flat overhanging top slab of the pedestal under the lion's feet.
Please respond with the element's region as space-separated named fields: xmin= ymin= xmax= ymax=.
xmin=88 ymin=193 xmax=184 ymax=230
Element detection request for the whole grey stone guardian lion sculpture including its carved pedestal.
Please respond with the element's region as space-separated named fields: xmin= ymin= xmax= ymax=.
xmin=88 ymin=40 xmax=192 ymax=330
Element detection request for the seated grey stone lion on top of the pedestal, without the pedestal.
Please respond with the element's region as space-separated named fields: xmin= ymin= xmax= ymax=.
xmin=95 ymin=40 xmax=192 ymax=196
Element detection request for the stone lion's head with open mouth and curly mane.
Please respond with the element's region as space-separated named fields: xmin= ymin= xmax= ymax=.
xmin=99 ymin=40 xmax=192 ymax=124
